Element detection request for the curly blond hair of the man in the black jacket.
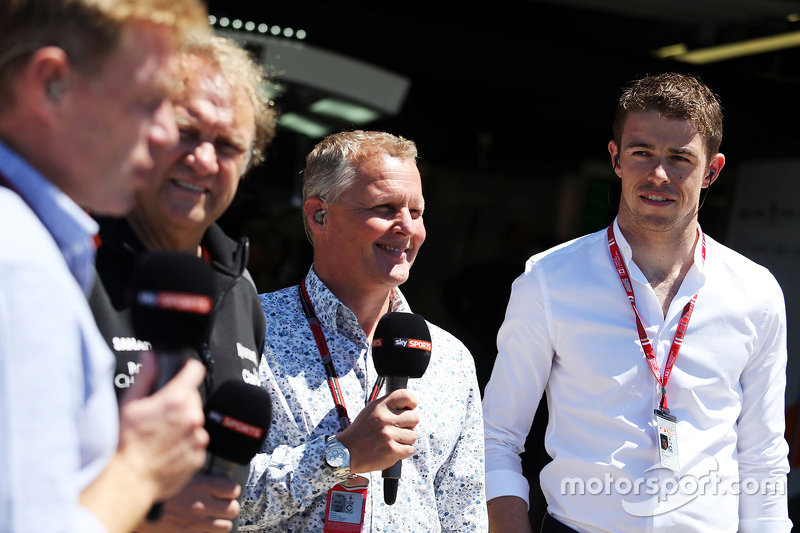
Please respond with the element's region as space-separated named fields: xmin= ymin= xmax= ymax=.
xmin=180 ymin=32 xmax=277 ymax=173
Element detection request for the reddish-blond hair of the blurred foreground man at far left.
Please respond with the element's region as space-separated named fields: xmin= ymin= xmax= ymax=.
xmin=0 ymin=0 xmax=210 ymax=111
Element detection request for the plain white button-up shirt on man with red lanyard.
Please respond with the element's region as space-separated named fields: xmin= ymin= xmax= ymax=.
xmin=483 ymin=217 xmax=791 ymax=533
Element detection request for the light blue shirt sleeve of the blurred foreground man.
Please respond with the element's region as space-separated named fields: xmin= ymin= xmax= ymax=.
xmin=0 ymin=265 xmax=105 ymax=533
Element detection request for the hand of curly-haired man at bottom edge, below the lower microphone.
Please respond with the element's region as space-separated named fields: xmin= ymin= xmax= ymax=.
xmin=136 ymin=475 xmax=241 ymax=533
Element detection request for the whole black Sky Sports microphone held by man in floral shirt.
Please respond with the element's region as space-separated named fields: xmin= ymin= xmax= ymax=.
xmin=372 ymin=312 xmax=432 ymax=505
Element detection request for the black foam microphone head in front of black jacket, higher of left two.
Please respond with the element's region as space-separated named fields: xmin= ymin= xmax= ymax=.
xmin=129 ymin=251 xmax=214 ymax=348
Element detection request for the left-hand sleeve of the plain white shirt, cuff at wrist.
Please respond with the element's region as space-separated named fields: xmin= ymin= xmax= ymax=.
xmin=483 ymin=260 xmax=553 ymax=505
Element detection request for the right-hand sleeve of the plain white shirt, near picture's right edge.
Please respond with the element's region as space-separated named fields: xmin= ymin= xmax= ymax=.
xmin=737 ymin=278 xmax=792 ymax=533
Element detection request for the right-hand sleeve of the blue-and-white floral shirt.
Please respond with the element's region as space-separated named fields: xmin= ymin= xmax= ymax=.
xmin=434 ymin=342 xmax=489 ymax=532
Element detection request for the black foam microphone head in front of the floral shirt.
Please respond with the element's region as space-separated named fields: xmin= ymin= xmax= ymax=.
xmin=372 ymin=312 xmax=431 ymax=378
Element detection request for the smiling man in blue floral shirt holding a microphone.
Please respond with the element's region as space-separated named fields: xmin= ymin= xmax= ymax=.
xmin=240 ymin=131 xmax=488 ymax=533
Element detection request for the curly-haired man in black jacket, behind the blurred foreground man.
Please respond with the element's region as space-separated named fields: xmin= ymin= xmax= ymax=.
xmin=90 ymin=35 xmax=275 ymax=533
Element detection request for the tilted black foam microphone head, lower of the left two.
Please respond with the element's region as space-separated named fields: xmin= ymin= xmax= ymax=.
xmin=205 ymin=380 xmax=272 ymax=465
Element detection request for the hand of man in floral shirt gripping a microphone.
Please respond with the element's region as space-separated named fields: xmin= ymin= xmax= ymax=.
xmin=337 ymin=389 xmax=419 ymax=474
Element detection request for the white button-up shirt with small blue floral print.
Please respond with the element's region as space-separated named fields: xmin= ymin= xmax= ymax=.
xmin=239 ymin=267 xmax=488 ymax=533
